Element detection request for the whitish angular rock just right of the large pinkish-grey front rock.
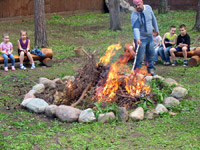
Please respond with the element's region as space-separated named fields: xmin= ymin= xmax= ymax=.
xmin=78 ymin=108 xmax=96 ymax=122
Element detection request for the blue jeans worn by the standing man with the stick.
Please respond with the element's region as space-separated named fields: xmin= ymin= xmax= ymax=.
xmin=134 ymin=37 xmax=155 ymax=69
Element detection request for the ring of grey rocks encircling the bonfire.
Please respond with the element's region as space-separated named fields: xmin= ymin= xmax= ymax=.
xmin=21 ymin=75 xmax=188 ymax=123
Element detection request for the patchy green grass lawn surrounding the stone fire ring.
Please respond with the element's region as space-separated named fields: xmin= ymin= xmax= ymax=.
xmin=0 ymin=11 xmax=200 ymax=150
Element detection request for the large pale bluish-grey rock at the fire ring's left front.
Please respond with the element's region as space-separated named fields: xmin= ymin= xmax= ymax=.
xmin=26 ymin=98 xmax=49 ymax=113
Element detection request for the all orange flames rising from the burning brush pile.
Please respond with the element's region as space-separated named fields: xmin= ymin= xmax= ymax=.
xmin=96 ymin=44 xmax=150 ymax=102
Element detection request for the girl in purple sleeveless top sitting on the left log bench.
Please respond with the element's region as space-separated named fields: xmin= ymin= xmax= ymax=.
xmin=17 ymin=30 xmax=35 ymax=70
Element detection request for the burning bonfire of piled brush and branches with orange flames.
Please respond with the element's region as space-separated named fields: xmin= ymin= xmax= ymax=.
xmin=37 ymin=44 xmax=151 ymax=108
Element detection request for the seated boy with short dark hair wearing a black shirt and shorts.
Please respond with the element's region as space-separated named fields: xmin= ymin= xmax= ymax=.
xmin=170 ymin=24 xmax=190 ymax=66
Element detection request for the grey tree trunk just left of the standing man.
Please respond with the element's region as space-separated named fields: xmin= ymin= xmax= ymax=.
xmin=109 ymin=0 xmax=121 ymax=31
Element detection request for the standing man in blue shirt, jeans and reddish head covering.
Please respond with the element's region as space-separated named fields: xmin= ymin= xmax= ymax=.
xmin=131 ymin=0 xmax=159 ymax=75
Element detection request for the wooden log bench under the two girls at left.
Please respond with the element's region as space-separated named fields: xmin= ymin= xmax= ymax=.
xmin=0 ymin=48 xmax=53 ymax=67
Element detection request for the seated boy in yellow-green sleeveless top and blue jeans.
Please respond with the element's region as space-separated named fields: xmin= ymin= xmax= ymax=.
xmin=158 ymin=26 xmax=177 ymax=65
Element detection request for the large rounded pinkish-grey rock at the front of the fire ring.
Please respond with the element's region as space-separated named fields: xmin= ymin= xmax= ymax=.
xmin=56 ymin=105 xmax=81 ymax=122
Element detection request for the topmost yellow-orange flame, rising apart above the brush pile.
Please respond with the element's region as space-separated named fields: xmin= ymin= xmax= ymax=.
xmin=98 ymin=43 xmax=122 ymax=65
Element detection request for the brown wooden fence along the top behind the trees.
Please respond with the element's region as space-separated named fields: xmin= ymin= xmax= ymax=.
xmin=0 ymin=0 xmax=198 ymax=18
